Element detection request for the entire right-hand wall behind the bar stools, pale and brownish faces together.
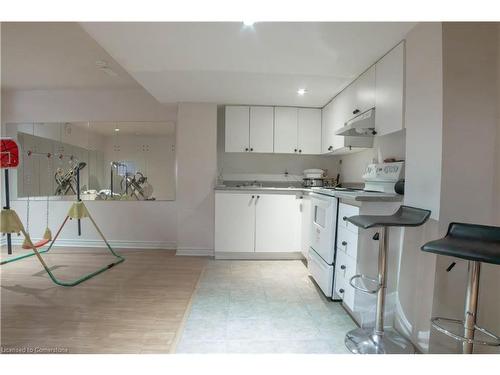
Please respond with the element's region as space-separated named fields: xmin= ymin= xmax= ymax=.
xmin=395 ymin=23 xmax=500 ymax=353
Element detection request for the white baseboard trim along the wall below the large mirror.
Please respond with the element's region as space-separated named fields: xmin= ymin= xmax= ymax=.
xmin=0 ymin=239 xmax=177 ymax=250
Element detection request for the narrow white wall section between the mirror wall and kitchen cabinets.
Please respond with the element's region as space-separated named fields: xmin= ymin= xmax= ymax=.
xmin=176 ymin=103 xmax=217 ymax=255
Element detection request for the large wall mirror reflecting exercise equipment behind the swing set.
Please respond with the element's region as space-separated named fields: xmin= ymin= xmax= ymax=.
xmin=3 ymin=122 xmax=176 ymax=201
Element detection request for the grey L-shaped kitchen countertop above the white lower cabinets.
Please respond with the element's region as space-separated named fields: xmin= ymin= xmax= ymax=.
xmin=215 ymin=186 xmax=403 ymax=202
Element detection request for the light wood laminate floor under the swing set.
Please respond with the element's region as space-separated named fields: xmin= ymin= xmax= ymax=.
xmin=0 ymin=247 xmax=207 ymax=353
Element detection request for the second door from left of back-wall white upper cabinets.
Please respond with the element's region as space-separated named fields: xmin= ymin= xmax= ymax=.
xmin=250 ymin=107 xmax=274 ymax=152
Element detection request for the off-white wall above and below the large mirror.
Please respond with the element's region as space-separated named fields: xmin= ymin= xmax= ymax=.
xmin=2 ymin=89 xmax=180 ymax=248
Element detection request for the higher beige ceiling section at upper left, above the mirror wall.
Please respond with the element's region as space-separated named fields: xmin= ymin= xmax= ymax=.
xmin=1 ymin=22 xmax=141 ymax=90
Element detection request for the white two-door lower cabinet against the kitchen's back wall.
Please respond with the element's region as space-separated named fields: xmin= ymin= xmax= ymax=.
xmin=215 ymin=191 xmax=302 ymax=259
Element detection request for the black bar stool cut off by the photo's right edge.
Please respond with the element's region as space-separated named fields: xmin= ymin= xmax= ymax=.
xmin=422 ymin=223 xmax=500 ymax=354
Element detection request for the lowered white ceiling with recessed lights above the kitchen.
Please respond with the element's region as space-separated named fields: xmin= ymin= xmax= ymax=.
xmin=82 ymin=22 xmax=415 ymax=106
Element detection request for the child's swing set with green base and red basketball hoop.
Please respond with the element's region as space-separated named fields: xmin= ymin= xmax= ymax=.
xmin=0 ymin=139 xmax=125 ymax=286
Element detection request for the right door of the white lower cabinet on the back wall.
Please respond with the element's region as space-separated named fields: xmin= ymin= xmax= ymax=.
xmin=255 ymin=194 xmax=301 ymax=252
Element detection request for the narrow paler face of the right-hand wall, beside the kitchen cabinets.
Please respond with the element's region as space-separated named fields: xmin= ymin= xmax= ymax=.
xmin=395 ymin=23 xmax=443 ymax=352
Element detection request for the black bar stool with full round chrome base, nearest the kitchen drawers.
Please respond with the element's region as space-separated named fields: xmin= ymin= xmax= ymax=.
xmin=345 ymin=206 xmax=431 ymax=354
